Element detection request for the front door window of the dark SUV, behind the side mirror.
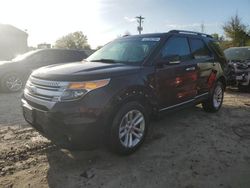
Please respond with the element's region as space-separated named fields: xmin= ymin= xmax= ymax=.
xmin=161 ymin=37 xmax=191 ymax=60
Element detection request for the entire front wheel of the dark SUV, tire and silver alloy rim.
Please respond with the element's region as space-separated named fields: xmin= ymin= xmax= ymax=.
xmin=108 ymin=102 xmax=149 ymax=155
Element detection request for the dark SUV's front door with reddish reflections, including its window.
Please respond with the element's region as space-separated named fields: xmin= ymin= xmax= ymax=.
xmin=156 ymin=36 xmax=197 ymax=109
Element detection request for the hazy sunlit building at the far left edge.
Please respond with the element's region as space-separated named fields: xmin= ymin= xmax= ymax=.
xmin=0 ymin=24 xmax=28 ymax=60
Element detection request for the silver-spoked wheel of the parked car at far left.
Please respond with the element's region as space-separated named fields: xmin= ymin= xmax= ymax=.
xmin=1 ymin=73 xmax=24 ymax=93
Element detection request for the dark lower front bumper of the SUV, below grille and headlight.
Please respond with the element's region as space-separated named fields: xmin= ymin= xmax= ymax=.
xmin=22 ymin=98 xmax=106 ymax=149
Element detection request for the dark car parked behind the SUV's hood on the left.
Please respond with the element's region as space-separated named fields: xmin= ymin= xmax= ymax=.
xmin=0 ymin=49 xmax=88 ymax=92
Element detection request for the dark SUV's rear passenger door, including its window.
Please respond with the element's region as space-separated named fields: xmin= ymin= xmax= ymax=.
xmin=189 ymin=36 xmax=216 ymax=96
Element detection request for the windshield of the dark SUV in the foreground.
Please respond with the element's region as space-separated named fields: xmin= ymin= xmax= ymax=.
xmin=87 ymin=38 xmax=160 ymax=65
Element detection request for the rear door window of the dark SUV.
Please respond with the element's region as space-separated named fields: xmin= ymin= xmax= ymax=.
xmin=190 ymin=39 xmax=211 ymax=59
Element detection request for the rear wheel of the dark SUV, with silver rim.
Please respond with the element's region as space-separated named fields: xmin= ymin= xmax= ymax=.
xmin=202 ymin=81 xmax=225 ymax=112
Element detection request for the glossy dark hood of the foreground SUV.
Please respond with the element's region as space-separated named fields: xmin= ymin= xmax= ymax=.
xmin=32 ymin=61 xmax=141 ymax=81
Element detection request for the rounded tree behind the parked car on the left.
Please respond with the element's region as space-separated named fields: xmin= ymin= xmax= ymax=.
xmin=55 ymin=31 xmax=90 ymax=50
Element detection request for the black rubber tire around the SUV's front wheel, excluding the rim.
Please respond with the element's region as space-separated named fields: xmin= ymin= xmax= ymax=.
xmin=109 ymin=102 xmax=149 ymax=155
